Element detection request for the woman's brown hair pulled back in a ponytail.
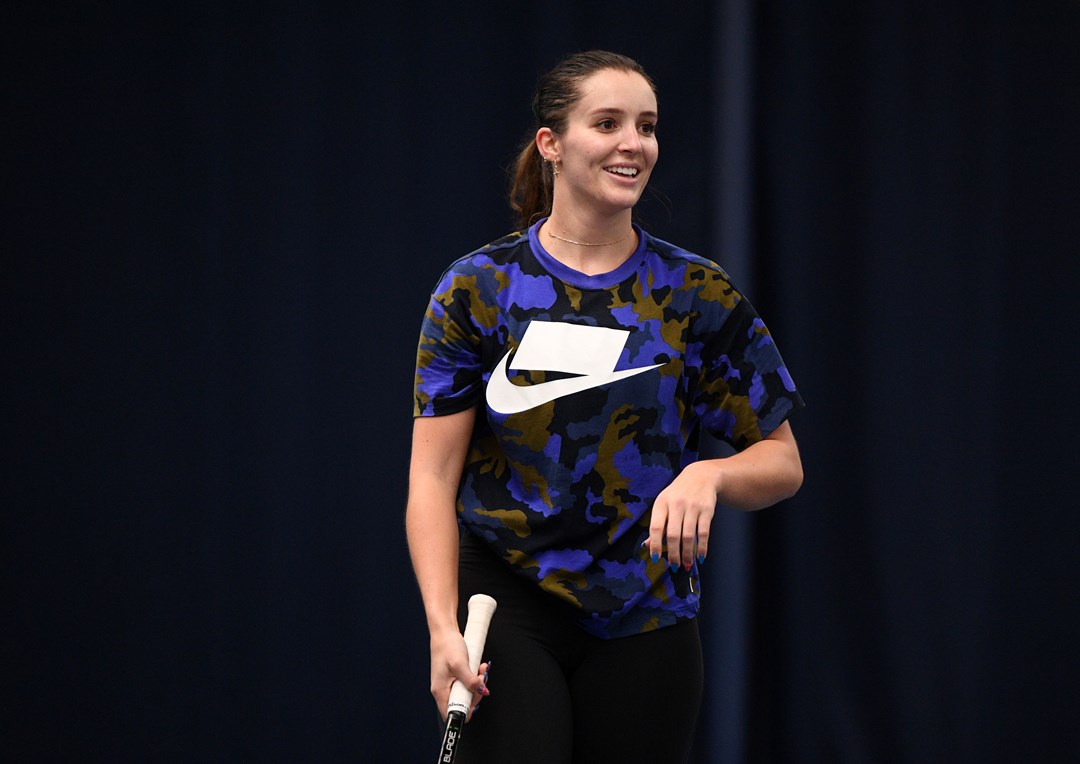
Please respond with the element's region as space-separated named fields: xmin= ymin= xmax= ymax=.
xmin=510 ymin=51 xmax=657 ymax=228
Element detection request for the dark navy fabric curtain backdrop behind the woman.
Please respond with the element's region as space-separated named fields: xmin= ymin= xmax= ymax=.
xmin=6 ymin=0 xmax=1080 ymax=763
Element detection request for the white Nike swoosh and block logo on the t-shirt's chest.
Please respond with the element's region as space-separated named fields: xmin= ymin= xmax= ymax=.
xmin=487 ymin=321 xmax=663 ymax=414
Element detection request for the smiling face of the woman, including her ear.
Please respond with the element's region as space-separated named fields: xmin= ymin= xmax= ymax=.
xmin=549 ymin=69 xmax=660 ymax=214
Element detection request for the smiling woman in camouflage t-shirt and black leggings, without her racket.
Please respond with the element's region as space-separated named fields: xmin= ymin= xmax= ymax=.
xmin=406 ymin=51 xmax=802 ymax=764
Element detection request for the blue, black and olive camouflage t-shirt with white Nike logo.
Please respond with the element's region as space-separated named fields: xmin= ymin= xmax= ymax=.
xmin=414 ymin=220 xmax=802 ymax=639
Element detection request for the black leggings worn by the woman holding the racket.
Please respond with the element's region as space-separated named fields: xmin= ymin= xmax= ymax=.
xmin=457 ymin=533 xmax=703 ymax=764
